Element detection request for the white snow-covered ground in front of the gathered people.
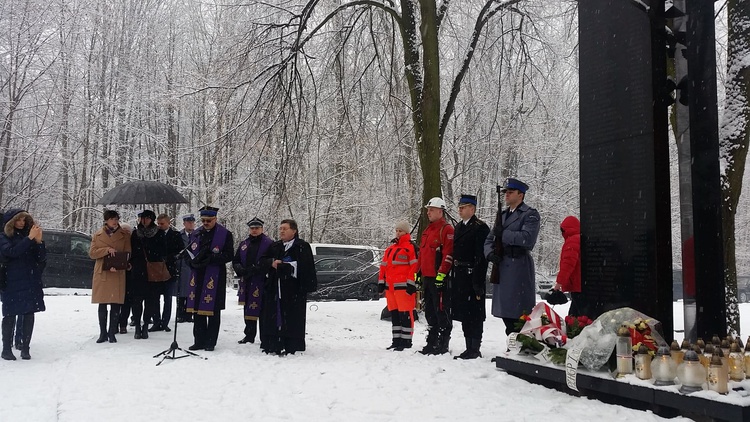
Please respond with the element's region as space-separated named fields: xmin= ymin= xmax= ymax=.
xmin=0 ymin=289 xmax=750 ymax=422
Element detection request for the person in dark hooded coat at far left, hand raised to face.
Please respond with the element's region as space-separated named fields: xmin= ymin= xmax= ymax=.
xmin=0 ymin=209 xmax=47 ymax=360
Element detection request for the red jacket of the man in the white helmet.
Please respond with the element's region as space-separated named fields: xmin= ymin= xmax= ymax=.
xmin=419 ymin=218 xmax=453 ymax=277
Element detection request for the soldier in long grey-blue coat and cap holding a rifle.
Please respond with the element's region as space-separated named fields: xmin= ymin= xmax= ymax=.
xmin=484 ymin=179 xmax=540 ymax=334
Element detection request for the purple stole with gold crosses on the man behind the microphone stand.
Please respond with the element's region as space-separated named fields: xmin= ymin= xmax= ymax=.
xmin=186 ymin=224 xmax=229 ymax=316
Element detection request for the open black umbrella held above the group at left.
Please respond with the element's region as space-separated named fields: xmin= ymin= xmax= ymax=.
xmin=96 ymin=180 xmax=188 ymax=205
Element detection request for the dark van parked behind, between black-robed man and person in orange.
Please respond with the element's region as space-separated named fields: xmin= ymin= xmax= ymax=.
xmin=308 ymin=256 xmax=380 ymax=300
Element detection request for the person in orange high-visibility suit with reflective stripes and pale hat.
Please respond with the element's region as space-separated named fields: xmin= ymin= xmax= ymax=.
xmin=378 ymin=221 xmax=417 ymax=352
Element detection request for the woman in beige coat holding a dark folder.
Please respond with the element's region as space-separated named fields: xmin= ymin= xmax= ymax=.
xmin=89 ymin=210 xmax=131 ymax=343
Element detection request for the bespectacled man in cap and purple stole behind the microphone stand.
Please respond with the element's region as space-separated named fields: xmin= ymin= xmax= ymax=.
xmin=186 ymin=206 xmax=234 ymax=351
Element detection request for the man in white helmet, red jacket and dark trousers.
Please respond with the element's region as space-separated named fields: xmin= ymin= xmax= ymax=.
xmin=419 ymin=197 xmax=453 ymax=355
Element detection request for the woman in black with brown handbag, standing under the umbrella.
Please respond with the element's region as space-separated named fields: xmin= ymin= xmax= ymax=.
xmin=129 ymin=210 xmax=169 ymax=339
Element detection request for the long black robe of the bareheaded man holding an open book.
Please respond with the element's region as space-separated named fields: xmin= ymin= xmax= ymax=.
xmin=260 ymin=238 xmax=317 ymax=353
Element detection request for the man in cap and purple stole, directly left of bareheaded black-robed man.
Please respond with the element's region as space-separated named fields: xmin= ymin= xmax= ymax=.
xmin=232 ymin=217 xmax=273 ymax=344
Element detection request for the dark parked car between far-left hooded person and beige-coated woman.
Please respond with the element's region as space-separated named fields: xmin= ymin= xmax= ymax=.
xmin=42 ymin=230 xmax=95 ymax=289
